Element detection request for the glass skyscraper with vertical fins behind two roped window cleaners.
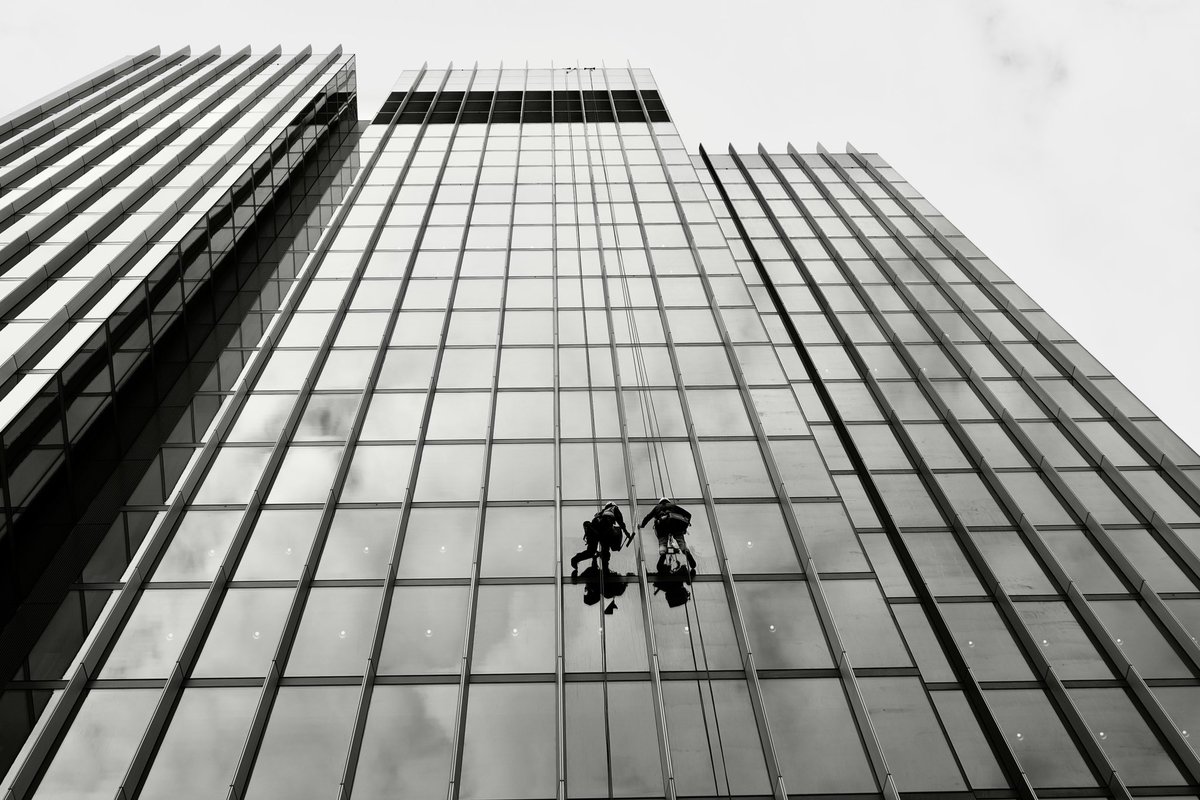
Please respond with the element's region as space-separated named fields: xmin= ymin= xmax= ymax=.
xmin=0 ymin=54 xmax=1200 ymax=800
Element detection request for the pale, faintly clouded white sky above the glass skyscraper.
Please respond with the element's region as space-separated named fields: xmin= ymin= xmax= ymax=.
xmin=0 ymin=0 xmax=1200 ymax=449
